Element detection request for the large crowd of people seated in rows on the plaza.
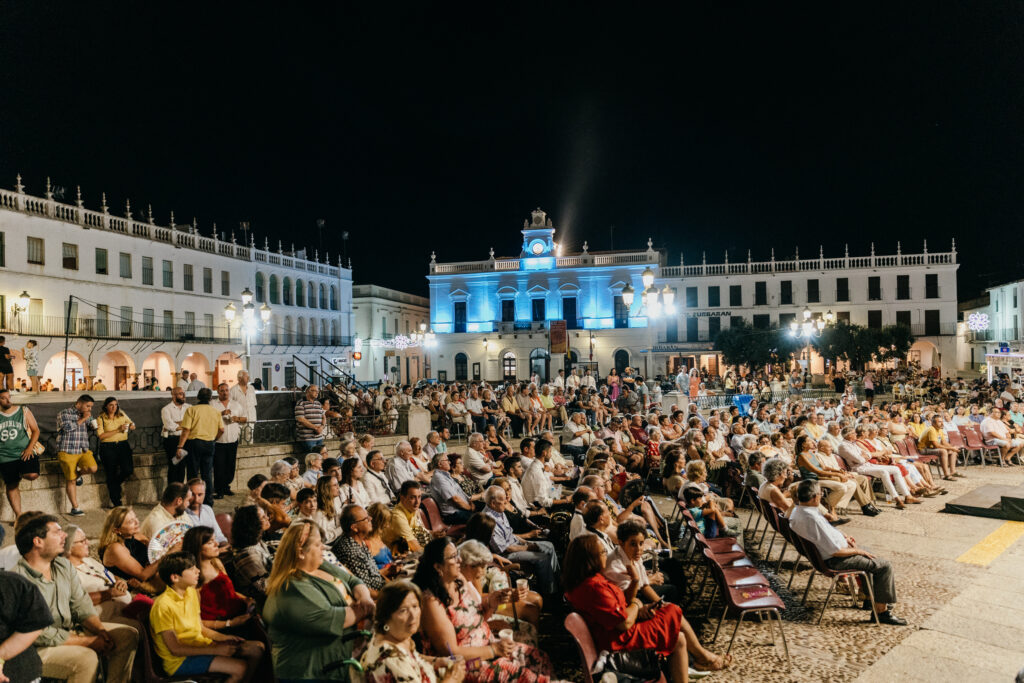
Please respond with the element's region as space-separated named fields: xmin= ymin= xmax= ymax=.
xmin=8 ymin=373 xmax=1024 ymax=683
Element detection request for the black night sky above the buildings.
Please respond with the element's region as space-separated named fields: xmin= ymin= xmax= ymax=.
xmin=0 ymin=0 xmax=1024 ymax=299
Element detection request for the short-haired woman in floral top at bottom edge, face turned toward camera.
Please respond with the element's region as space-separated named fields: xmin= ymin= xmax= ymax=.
xmin=359 ymin=581 xmax=466 ymax=683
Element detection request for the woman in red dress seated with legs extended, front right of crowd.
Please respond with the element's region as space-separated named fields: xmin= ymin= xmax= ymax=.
xmin=563 ymin=533 xmax=689 ymax=683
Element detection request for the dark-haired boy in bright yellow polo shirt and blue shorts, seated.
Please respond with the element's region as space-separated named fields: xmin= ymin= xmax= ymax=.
xmin=150 ymin=553 xmax=263 ymax=683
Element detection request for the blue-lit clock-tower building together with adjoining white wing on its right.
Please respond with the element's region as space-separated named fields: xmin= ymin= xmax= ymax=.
xmin=427 ymin=209 xmax=958 ymax=381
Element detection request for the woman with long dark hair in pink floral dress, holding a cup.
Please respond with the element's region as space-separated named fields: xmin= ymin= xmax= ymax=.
xmin=413 ymin=538 xmax=551 ymax=683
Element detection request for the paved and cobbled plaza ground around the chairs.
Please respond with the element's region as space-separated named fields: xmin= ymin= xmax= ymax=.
xmin=7 ymin=466 xmax=1024 ymax=683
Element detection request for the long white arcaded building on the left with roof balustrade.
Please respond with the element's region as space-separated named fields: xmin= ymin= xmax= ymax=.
xmin=0 ymin=177 xmax=352 ymax=389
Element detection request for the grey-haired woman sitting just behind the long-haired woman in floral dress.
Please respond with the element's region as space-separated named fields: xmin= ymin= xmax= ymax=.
xmin=459 ymin=541 xmax=544 ymax=646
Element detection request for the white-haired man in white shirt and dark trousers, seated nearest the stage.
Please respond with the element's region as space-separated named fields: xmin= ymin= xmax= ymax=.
xmin=790 ymin=479 xmax=906 ymax=626
